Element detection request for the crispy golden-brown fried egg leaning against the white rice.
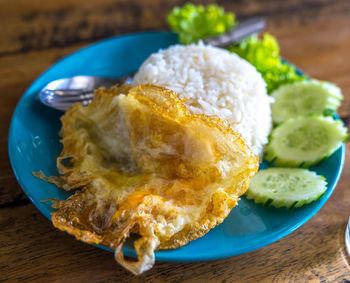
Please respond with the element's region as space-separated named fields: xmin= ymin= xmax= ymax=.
xmin=47 ymin=85 xmax=258 ymax=275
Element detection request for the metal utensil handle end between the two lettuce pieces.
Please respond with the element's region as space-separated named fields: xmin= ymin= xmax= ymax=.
xmin=203 ymin=17 xmax=266 ymax=47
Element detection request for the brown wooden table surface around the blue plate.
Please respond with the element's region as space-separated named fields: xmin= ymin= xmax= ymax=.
xmin=0 ymin=0 xmax=350 ymax=282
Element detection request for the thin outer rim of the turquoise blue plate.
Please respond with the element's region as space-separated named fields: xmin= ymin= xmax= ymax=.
xmin=7 ymin=31 xmax=346 ymax=262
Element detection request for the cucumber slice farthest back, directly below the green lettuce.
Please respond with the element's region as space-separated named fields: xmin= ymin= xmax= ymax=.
xmin=271 ymin=80 xmax=343 ymax=124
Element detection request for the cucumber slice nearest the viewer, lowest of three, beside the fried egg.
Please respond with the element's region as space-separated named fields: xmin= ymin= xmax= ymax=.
xmin=247 ymin=168 xmax=327 ymax=208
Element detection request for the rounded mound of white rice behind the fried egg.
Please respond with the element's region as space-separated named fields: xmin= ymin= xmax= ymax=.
xmin=134 ymin=43 xmax=272 ymax=156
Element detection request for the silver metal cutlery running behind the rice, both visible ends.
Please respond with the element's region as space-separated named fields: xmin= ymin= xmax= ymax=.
xmin=39 ymin=18 xmax=266 ymax=111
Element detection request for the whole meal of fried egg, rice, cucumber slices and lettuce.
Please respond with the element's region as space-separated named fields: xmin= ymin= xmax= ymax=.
xmin=32 ymin=4 xmax=349 ymax=275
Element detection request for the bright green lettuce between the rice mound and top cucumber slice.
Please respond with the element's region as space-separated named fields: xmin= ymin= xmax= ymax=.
xmin=229 ymin=33 xmax=305 ymax=93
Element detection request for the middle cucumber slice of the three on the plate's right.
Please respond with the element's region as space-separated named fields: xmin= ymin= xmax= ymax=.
xmin=265 ymin=116 xmax=348 ymax=167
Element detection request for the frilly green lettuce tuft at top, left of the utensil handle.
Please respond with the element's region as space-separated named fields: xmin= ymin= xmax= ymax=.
xmin=167 ymin=3 xmax=237 ymax=44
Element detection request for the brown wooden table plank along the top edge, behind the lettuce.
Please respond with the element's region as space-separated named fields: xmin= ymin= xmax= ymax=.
xmin=0 ymin=0 xmax=350 ymax=55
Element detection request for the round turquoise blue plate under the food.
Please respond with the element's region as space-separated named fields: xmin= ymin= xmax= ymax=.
xmin=9 ymin=32 xmax=345 ymax=261
